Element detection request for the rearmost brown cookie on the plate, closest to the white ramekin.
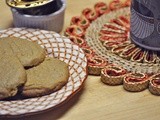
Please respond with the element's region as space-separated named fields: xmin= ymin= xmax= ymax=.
xmin=0 ymin=37 xmax=45 ymax=67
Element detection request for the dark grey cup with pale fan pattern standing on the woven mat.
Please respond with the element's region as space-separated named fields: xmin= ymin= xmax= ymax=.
xmin=130 ymin=0 xmax=160 ymax=51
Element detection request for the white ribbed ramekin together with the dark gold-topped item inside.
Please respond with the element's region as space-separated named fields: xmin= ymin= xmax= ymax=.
xmin=6 ymin=0 xmax=66 ymax=32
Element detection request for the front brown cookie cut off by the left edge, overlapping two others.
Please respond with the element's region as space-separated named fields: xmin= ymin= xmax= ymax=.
xmin=0 ymin=55 xmax=27 ymax=100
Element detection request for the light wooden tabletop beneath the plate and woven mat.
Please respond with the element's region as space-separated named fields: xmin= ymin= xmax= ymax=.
xmin=0 ymin=0 xmax=160 ymax=120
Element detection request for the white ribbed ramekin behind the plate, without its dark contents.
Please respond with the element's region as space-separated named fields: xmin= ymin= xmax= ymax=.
xmin=11 ymin=0 xmax=66 ymax=32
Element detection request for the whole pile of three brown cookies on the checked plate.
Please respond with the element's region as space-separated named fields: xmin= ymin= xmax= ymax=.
xmin=0 ymin=37 xmax=69 ymax=100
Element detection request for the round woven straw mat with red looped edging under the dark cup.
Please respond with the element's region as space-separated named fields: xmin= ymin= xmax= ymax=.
xmin=65 ymin=0 xmax=160 ymax=95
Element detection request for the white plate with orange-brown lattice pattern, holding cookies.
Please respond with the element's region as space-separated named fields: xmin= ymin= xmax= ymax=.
xmin=0 ymin=28 xmax=87 ymax=116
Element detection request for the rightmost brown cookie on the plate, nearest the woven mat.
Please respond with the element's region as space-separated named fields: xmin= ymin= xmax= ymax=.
xmin=22 ymin=57 xmax=69 ymax=97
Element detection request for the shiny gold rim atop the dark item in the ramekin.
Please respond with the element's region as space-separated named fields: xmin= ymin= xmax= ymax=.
xmin=6 ymin=0 xmax=54 ymax=9
